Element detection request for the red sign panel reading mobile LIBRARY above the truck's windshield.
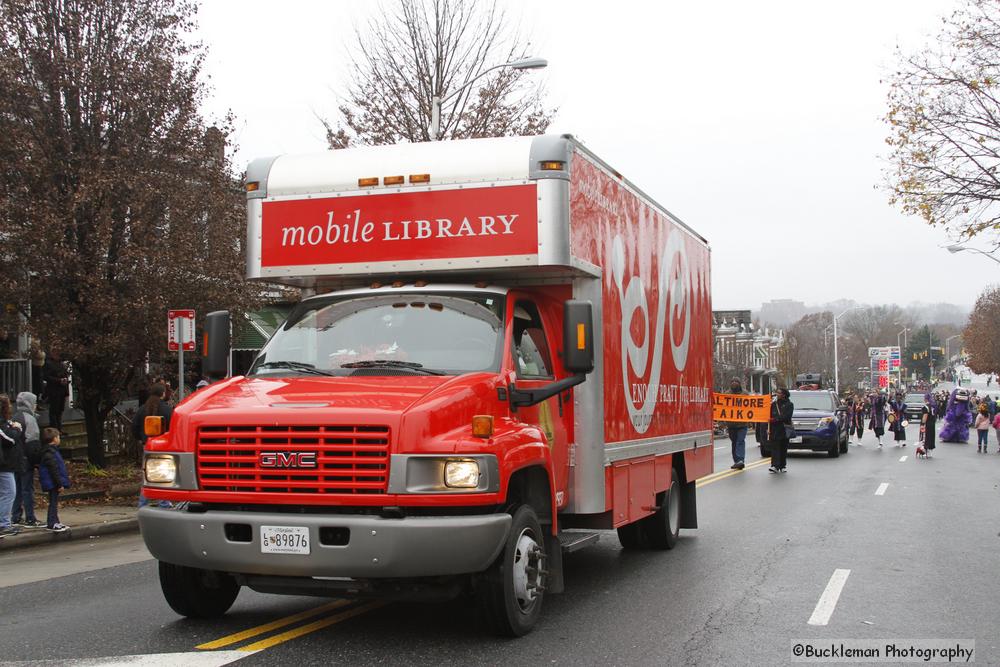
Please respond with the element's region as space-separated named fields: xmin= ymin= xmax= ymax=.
xmin=260 ymin=184 xmax=538 ymax=268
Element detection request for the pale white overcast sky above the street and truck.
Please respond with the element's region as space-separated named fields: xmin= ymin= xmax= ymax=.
xmin=193 ymin=0 xmax=1000 ymax=309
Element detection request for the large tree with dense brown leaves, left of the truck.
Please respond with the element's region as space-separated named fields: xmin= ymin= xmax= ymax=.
xmin=0 ymin=0 xmax=255 ymax=465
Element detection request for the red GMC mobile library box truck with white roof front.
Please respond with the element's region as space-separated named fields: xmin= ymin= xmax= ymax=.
xmin=139 ymin=135 xmax=713 ymax=635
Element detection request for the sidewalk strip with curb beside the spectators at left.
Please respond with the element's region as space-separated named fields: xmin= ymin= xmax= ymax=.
xmin=0 ymin=499 xmax=139 ymax=554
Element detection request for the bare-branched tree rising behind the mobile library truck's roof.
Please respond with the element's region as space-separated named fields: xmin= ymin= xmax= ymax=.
xmin=321 ymin=0 xmax=555 ymax=148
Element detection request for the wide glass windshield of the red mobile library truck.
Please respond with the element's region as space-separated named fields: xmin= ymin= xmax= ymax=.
xmin=248 ymin=293 xmax=504 ymax=376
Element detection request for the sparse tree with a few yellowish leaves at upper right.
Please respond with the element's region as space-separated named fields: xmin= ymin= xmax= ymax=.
xmin=885 ymin=0 xmax=1000 ymax=244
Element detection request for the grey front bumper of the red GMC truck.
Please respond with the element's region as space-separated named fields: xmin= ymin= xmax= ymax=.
xmin=139 ymin=506 xmax=511 ymax=579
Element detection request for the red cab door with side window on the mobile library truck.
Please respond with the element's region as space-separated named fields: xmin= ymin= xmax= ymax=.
xmin=511 ymin=296 xmax=572 ymax=507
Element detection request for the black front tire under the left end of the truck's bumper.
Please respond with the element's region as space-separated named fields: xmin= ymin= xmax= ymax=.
xmin=160 ymin=562 xmax=240 ymax=618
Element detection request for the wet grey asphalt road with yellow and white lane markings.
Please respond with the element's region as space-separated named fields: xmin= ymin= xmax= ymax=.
xmin=0 ymin=429 xmax=1000 ymax=665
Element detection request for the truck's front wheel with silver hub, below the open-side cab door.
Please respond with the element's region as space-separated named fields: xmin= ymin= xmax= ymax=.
xmin=479 ymin=505 xmax=548 ymax=637
